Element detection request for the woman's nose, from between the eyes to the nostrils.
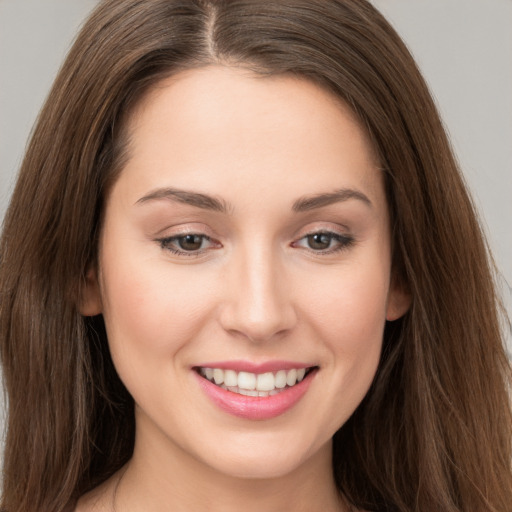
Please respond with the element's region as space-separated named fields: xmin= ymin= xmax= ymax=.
xmin=220 ymin=246 xmax=297 ymax=343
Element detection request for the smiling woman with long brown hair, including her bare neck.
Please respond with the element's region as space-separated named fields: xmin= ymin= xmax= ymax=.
xmin=0 ymin=0 xmax=512 ymax=512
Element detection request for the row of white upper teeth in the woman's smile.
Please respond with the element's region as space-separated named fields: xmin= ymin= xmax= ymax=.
xmin=200 ymin=368 xmax=306 ymax=391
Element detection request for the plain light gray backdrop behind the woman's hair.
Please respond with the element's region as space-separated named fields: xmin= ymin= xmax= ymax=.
xmin=0 ymin=0 xmax=512 ymax=448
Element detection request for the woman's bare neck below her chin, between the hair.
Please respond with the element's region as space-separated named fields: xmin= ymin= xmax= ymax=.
xmin=115 ymin=412 xmax=346 ymax=512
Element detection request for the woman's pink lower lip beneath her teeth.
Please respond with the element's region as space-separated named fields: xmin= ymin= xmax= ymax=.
xmin=194 ymin=370 xmax=317 ymax=420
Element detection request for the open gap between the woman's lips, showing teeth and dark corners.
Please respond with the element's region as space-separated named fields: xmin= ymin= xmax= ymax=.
xmin=194 ymin=366 xmax=318 ymax=397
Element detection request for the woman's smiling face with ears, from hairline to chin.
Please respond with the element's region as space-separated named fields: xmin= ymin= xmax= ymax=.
xmin=82 ymin=67 xmax=407 ymax=477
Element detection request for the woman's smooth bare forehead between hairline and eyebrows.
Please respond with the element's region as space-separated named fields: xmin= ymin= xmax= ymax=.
xmin=114 ymin=66 xmax=382 ymax=210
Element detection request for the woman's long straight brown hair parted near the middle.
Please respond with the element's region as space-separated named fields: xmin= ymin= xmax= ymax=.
xmin=0 ymin=0 xmax=512 ymax=512
